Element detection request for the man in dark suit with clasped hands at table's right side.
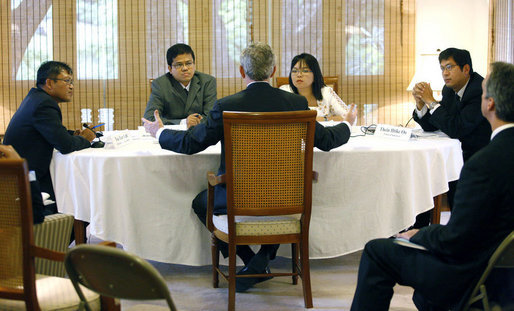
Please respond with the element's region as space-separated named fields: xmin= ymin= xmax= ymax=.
xmin=412 ymin=48 xmax=491 ymax=228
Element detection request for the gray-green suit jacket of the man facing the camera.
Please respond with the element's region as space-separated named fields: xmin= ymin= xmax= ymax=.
xmin=144 ymin=71 xmax=216 ymax=124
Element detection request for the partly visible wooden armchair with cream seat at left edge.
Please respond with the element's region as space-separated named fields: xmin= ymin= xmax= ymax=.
xmin=0 ymin=159 xmax=115 ymax=310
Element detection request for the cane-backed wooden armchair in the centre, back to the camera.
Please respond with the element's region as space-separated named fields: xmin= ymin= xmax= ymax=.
xmin=207 ymin=110 xmax=316 ymax=310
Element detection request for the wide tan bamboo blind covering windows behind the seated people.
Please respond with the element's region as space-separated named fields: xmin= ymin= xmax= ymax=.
xmin=0 ymin=0 xmax=476 ymax=134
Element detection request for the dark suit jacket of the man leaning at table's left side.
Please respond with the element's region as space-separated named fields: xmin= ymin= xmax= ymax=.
xmin=3 ymin=88 xmax=91 ymax=223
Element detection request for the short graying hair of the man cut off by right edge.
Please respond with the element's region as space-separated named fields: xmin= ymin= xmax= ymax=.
xmin=485 ymin=62 xmax=514 ymax=122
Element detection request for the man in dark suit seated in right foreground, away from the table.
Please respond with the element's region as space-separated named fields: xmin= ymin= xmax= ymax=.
xmin=351 ymin=62 xmax=514 ymax=311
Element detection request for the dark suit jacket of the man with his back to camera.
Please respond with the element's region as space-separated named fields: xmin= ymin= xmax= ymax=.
xmin=159 ymin=82 xmax=350 ymax=214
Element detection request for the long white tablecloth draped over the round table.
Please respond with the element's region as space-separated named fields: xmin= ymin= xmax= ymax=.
xmin=51 ymin=127 xmax=462 ymax=265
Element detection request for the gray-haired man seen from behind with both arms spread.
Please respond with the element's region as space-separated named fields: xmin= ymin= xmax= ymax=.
xmin=143 ymin=43 xmax=357 ymax=292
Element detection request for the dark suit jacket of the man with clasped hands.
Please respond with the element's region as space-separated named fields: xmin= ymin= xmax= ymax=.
xmin=413 ymin=72 xmax=491 ymax=161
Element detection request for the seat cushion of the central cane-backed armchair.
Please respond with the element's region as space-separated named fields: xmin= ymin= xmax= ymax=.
xmin=212 ymin=215 xmax=301 ymax=236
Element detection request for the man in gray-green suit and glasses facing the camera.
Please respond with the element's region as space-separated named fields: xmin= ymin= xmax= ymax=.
xmin=144 ymin=43 xmax=216 ymax=127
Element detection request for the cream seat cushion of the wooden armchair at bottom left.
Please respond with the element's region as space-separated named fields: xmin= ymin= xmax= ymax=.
xmin=0 ymin=274 xmax=100 ymax=311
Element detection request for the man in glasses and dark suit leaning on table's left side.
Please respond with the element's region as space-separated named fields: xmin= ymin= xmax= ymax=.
xmin=3 ymin=61 xmax=96 ymax=223
